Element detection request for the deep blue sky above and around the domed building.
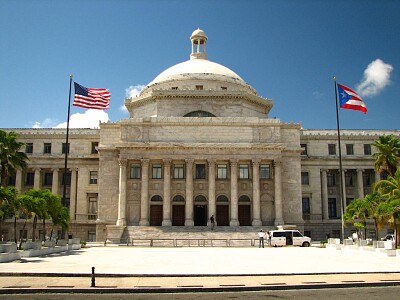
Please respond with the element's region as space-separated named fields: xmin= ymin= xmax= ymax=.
xmin=0 ymin=0 xmax=400 ymax=129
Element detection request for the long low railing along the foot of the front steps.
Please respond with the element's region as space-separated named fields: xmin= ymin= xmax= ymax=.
xmin=126 ymin=238 xmax=258 ymax=247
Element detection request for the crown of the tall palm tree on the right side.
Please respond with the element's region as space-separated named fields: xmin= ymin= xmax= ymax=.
xmin=372 ymin=135 xmax=400 ymax=176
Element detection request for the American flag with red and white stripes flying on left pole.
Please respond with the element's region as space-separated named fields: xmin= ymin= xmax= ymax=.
xmin=73 ymin=82 xmax=111 ymax=109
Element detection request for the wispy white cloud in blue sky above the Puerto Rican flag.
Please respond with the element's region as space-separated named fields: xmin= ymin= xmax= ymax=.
xmin=357 ymin=58 xmax=393 ymax=96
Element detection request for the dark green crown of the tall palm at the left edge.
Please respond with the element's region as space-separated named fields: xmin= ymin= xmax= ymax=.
xmin=0 ymin=130 xmax=28 ymax=186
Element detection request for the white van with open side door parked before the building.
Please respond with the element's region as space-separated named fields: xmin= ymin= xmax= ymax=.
xmin=269 ymin=229 xmax=311 ymax=247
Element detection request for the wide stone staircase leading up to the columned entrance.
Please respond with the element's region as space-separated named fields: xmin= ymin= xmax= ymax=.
xmin=121 ymin=226 xmax=275 ymax=247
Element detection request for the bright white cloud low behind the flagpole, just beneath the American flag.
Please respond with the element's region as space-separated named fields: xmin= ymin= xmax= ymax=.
xmin=54 ymin=109 xmax=110 ymax=128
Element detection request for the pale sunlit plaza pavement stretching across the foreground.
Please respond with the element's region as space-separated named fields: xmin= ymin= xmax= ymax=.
xmin=0 ymin=246 xmax=400 ymax=294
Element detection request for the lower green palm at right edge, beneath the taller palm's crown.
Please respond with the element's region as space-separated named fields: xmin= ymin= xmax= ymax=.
xmin=374 ymin=169 xmax=400 ymax=246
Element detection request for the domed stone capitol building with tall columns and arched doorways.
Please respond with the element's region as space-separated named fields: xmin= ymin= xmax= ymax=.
xmin=2 ymin=29 xmax=400 ymax=243
